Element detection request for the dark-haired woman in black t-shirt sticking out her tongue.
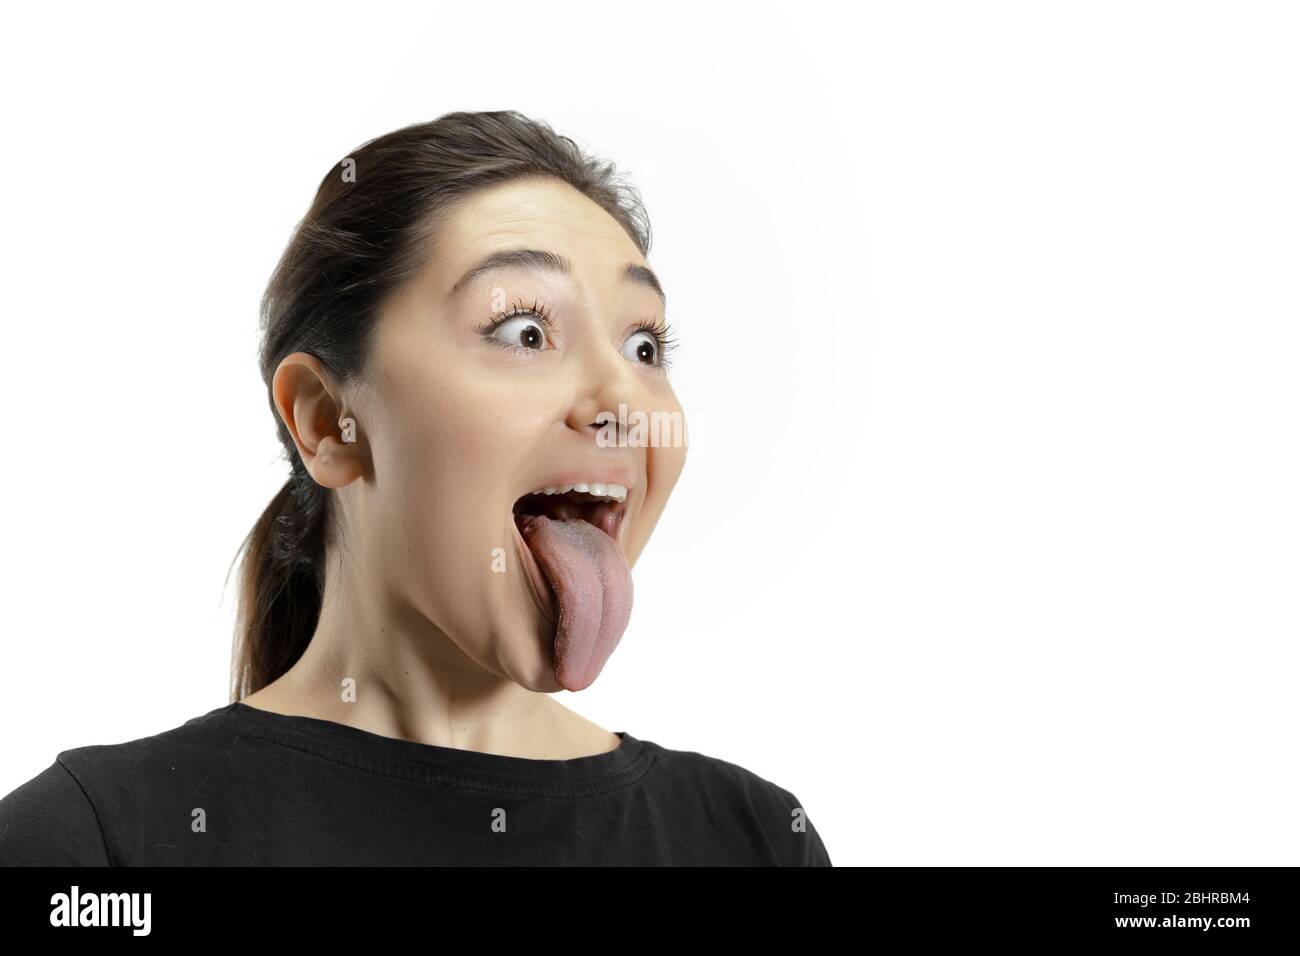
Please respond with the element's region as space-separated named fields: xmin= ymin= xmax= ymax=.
xmin=0 ymin=111 xmax=831 ymax=865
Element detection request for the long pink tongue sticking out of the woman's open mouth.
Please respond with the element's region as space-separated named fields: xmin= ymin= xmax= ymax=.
xmin=519 ymin=515 xmax=632 ymax=691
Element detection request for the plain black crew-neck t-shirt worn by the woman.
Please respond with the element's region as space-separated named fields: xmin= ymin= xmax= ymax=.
xmin=0 ymin=702 xmax=831 ymax=866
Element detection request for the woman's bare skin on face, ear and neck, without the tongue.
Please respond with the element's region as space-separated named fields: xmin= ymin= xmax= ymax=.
xmin=243 ymin=177 xmax=686 ymax=760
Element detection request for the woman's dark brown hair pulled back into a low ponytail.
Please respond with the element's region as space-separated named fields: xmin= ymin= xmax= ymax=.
xmin=231 ymin=111 xmax=650 ymax=700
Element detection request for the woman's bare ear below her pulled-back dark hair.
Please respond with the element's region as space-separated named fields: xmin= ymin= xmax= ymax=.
xmin=270 ymin=352 xmax=365 ymax=488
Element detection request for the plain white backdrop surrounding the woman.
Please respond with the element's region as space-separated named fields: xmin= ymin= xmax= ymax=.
xmin=0 ymin=0 xmax=1300 ymax=865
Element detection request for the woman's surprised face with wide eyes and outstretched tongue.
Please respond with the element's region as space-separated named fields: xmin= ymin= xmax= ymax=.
xmin=347 ymin=177 xmax=686 ymax=692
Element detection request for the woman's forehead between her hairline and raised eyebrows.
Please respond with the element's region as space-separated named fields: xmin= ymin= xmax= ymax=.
xmin=434 ymin=177 xmax=646 ymax=274
